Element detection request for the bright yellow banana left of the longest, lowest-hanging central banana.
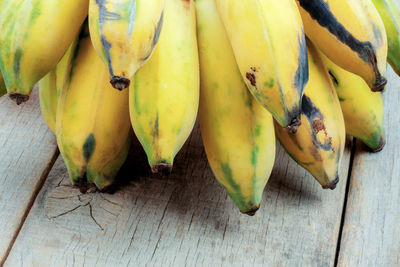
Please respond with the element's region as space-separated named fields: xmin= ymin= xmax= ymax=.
xmin=129 ymin=0 xmax=200 ymax=173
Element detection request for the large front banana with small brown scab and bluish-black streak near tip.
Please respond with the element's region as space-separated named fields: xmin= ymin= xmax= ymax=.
xmin=215 ymin=0 xmax=308 ymax=132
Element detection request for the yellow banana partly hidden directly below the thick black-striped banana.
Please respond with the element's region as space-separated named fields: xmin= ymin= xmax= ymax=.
xmin=319 ymin=48 xmax=386 ymax=152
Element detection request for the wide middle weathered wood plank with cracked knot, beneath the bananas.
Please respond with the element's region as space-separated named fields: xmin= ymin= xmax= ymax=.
xmin=5 ymin=120 xmax=349 ymax=267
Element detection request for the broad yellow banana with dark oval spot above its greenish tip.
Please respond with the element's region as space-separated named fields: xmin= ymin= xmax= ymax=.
xmin=56 ymin=26 xmax=131 ymax=192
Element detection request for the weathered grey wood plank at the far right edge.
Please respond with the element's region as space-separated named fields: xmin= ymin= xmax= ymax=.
xmin=338 ymin=70 xmax=400 ymax=266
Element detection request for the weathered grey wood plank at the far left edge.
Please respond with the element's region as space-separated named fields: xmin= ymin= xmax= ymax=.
xmin=0 ymin=90 xmax=57 ymax=265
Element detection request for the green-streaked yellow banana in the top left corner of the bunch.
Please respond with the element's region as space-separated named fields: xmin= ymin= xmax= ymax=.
xmin=0 ymin=0 xmax=89 ymax=104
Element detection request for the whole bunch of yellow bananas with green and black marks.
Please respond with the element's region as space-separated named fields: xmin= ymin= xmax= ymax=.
xmin=0 ymin=0 xmax=400 ymax=215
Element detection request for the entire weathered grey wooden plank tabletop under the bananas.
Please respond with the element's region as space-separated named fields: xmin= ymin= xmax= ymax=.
xmin=0 ymin=71 xmax=400 ymax=267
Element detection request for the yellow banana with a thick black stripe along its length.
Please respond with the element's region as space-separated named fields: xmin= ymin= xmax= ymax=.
xmin=297 ymin=0 xmax=387 ymax=91
